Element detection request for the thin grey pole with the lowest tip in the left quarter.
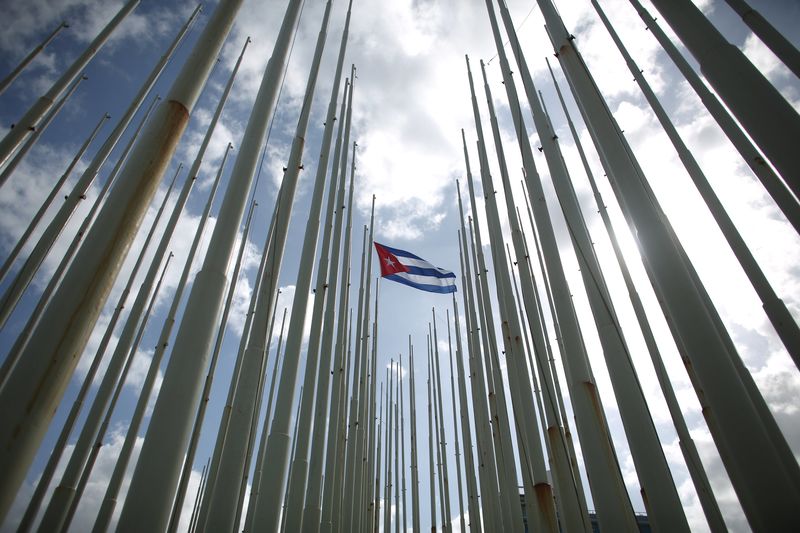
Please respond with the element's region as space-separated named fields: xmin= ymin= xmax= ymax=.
xmin=61 ymin=252 xmax=173 ymax=533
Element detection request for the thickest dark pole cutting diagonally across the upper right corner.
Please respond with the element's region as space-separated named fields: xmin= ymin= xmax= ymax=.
xmin=653 ymin=0 xmax=800 ymax=193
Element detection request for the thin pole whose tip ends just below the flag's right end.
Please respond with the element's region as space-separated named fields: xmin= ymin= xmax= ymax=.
xmin=448 ymin=296 xmax=483 ymax=533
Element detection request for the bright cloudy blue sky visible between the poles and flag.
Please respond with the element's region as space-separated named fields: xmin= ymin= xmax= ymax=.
xmin=0 ymin=0 xmax=800 ymax=531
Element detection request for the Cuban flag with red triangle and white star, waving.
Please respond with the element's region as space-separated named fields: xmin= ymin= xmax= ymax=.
xmin=374 ymin=242 xmax=456 ymax=294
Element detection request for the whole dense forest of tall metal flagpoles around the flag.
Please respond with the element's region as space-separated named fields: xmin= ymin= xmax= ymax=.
xmin=0 ymin=0 xmax=800 ymax=532
